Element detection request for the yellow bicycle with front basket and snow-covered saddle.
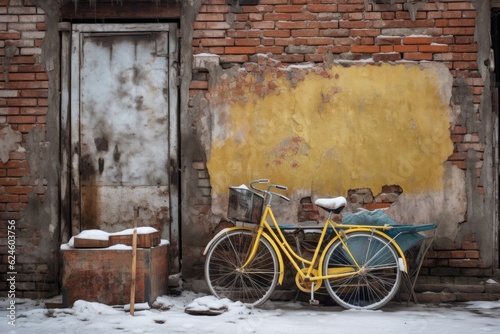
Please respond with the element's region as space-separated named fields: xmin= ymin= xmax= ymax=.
xmin=204 ymin=179 xmax=434 ymax=309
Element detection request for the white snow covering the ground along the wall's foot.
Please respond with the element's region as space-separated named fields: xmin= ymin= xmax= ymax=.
xmin=0 ymin=291 xmax=500 ymax=334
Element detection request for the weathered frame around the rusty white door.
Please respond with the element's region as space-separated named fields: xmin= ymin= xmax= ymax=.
xmin=59 ymin=22 xmax=180 ymax=272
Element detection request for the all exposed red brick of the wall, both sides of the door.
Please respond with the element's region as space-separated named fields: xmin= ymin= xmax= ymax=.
xmin=0 ymin=0 xmax=492 ymax=298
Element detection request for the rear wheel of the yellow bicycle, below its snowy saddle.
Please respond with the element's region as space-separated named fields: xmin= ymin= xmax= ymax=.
xmin=323 ymin=232 xmax=401 ymax=309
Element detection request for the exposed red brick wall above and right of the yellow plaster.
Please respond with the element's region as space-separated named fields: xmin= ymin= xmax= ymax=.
xmin=190 ymin=0 xmax=487 ymax=276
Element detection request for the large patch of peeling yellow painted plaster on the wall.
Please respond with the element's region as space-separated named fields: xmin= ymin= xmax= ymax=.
xmin=208 ymin=64 xmax=453 ymax=196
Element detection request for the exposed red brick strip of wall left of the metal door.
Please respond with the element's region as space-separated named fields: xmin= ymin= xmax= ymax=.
xmin=0 ymin=0 xmax=57 ymax=298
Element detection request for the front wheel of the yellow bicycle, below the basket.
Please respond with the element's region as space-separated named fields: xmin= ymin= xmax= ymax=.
xmin=205 ymin=230 xmax=279 ymax=306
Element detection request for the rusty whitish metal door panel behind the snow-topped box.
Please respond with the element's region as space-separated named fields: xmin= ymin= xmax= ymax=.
xmin=71 ymin=24 xmax=178 ymax=254
